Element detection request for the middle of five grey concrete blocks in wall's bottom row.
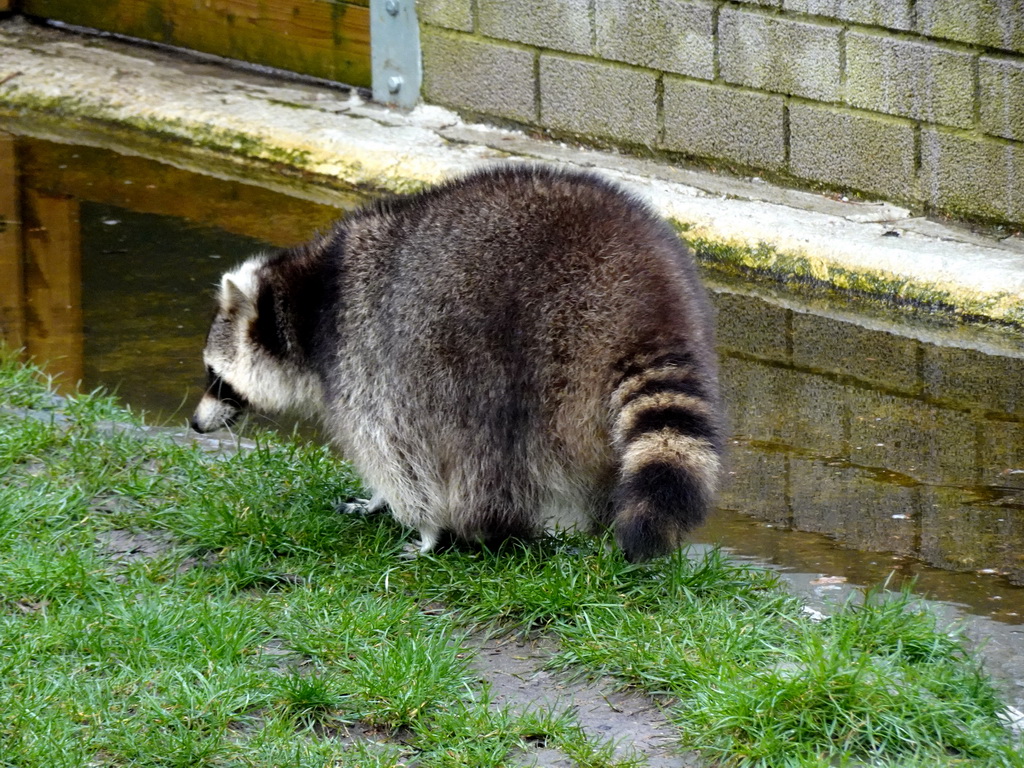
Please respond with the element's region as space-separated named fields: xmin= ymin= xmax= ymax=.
xmin=664 ymin=77 xmax=785 ymax=169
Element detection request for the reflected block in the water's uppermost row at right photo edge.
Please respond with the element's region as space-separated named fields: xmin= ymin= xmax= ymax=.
xmin=922 ymin=345 xmax=1024 ymax=417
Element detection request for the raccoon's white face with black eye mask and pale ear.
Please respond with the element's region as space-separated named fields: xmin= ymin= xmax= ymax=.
xmin=189 ymin=257 xmax=319 ymax=432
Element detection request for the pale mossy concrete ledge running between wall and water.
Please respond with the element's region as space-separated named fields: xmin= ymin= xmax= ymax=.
xmin=6 ymin=20 xmax=1024 ymax=329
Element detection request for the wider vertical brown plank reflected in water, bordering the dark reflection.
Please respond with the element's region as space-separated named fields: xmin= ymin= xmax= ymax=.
xmin=23 ymin=189 xmax=84 ymax=391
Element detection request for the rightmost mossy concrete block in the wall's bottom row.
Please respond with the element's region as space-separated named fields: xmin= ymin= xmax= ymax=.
xmin=921 ymin=129 xmax=1024 ymax=222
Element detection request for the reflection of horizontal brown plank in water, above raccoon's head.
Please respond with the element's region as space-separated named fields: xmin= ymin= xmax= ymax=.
xmin=20 ymin=141 xmax=352 ymax=246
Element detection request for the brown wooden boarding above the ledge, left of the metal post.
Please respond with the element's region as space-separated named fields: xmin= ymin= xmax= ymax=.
xmin=23 ymin=0 xmax=371 ymax=87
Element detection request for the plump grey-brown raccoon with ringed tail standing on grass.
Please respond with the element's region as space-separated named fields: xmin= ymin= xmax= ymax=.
xmin=191 ymin=166 xmax=723 ymax=561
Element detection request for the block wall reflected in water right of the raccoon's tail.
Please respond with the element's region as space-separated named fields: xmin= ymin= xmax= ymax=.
xmin=705 ymin=291 xmax=1024 ymax=621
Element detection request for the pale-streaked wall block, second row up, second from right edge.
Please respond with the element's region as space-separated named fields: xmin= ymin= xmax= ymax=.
xmin=846 ymin=32 xmax=974 ymax=128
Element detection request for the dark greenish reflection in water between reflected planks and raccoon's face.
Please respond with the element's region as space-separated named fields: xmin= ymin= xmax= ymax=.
xmin=82 ymin=203 xmax=267 ymax=425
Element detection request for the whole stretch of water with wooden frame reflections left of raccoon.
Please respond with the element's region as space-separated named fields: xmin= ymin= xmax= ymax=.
xmin=0 ymin=132 xmax=352 ymax=417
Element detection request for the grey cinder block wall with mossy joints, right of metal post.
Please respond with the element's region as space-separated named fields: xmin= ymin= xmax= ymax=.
xmin=417 ymin=0 xmax=1024 ymax=224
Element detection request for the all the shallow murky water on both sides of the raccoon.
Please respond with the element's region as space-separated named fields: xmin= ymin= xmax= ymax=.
xmin=6 ymin=134 xmax=1024 ymax=625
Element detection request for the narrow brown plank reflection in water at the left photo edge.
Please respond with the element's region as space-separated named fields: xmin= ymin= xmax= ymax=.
xmin=0 ymin=133 xmax=25 ymax=349
